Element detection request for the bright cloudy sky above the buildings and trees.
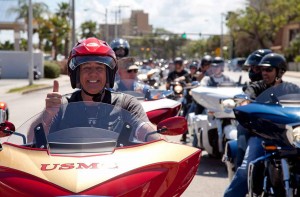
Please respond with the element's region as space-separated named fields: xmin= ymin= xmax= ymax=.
xmin=0 ymin=0 xmax=246 ymax=40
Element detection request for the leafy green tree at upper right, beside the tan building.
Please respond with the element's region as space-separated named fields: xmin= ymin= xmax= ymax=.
xmin=227 ymin=0 xmax=300 ymax=56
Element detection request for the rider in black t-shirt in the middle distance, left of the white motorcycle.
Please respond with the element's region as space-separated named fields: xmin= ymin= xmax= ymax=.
xmin=166 ymin=57 xmax=190 ymax=90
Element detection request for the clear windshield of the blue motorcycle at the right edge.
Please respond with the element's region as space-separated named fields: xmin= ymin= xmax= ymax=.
xmin=256 ymin=82 xmax=300 ymax=104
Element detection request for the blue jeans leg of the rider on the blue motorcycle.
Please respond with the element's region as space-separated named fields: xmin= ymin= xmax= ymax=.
xmin=224 ymin=136 xmax=265 ymax=197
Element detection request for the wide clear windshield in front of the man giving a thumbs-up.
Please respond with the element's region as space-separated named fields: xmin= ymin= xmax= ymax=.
xmin=7 ymin=102 xmax=159 ymax=154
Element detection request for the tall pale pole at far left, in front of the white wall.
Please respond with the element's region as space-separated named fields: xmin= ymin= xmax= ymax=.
xmin=28 ymin=0 xmax=33 ymax=85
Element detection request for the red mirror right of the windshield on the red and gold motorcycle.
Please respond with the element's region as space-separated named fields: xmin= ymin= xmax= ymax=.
xmin=157 ymin=116 xmax=187 ymax=135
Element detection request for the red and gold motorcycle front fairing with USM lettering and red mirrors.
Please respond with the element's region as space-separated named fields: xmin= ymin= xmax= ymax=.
xmin=0 ymin=103 xmax=201 ymax=197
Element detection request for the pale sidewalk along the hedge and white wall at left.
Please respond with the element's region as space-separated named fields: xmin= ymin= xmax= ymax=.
xmin=0 ymin=75 xmax=70 ymax=97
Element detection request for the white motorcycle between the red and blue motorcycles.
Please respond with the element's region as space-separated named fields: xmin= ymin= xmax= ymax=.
xmin=188 ymin=82 xmax=243 ymax=157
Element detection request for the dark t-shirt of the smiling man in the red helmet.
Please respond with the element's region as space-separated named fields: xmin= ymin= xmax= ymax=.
xmin=50 ymin=90 xmax=149 ymax=133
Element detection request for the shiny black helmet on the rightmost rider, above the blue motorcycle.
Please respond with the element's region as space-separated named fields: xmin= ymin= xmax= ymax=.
xmin=259 ymin=53 xmax=287 ymax=75
